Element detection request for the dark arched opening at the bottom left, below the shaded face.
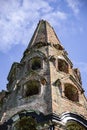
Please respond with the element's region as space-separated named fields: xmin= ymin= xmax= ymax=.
xmin=15 ymin=117 xmax=37 ymax=130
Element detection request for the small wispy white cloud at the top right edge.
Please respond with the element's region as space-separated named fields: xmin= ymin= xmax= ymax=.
xmin=66 ymin=0 xmax=80 ymax=14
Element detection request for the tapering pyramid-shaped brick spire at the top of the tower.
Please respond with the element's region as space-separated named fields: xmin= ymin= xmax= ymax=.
xmin=28 ymin=20 xmax=63 ymax=48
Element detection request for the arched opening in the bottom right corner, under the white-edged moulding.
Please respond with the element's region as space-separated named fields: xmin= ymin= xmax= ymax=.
xmin=66 ymin=121 xmax=86 ymax=130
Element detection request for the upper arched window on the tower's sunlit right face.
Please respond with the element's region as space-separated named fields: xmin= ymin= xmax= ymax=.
xmin=58 ymin=59 xmax=68 ymax=73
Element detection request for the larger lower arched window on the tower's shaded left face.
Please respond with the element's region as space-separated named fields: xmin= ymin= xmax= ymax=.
xmin=24 ymin=80 xmax=40 ymax=97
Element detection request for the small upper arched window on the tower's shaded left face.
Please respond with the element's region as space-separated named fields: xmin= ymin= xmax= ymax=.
xmin=31 ymin=57 xmax=42 ymax=70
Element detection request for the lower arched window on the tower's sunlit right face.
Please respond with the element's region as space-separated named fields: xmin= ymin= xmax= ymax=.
xmin=65 ymin=84 xmax=79 ymax=102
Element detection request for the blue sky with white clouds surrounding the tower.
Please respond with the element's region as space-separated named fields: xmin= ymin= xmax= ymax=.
xmin=0 ymin=0 xmax=87 ymax=97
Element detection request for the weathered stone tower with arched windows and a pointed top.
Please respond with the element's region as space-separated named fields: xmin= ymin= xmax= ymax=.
xmin=0 ymin=20 xmax=87 ymax=130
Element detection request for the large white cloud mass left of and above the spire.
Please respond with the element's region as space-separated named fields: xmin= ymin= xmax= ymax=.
xmin=0 ymin=0 xmax=67 ymax=52
